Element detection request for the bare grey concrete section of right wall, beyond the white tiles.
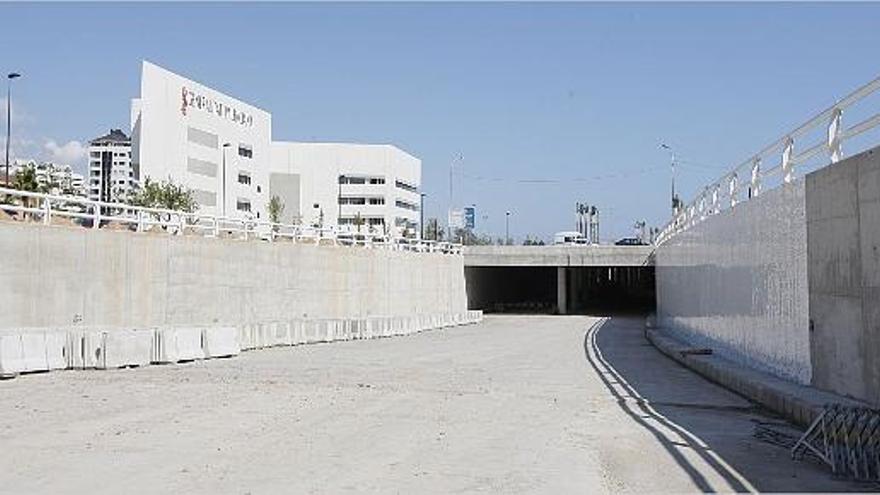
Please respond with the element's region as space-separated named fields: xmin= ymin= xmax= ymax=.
xmin=806 ymin=144 xmax=880 ymax=406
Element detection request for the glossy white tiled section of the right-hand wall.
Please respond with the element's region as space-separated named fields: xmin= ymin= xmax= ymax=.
xmin=656 ymin=180 xmax=812 ymax=384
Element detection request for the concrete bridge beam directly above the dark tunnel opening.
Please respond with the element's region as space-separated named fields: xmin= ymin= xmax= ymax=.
xmin=464 ymin=246 xmax=654 ymax=266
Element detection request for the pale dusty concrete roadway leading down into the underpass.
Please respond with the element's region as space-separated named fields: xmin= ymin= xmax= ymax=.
xmin=0 ymin=316 xmax=876 ymax=493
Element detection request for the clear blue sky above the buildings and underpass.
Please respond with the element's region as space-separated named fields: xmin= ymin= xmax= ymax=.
xmin=0 ymin=3 xmax=880 ymax=239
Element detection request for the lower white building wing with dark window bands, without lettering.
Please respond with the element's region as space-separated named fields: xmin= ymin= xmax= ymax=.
xmin=269 ymin=142 xmax=422 ymax=235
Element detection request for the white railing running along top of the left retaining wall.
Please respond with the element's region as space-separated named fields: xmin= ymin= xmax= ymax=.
xmin=0 ymin=187 xmax=462 ymax=255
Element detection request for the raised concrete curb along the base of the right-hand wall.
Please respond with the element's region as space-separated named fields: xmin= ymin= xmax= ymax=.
xmin=645 ymin=328 xmax=867 ymax=427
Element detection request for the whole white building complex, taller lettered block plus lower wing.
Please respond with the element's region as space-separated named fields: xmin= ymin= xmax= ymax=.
xmin=131 ymin=62 xmax=421 ymax=234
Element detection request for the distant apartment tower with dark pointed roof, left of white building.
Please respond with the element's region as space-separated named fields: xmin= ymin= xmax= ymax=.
xmin=88 ymin=129 xmax=139 ymax=203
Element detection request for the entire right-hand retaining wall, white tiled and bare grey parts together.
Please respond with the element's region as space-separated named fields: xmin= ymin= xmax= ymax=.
xmin=656 ymin=144 xmax=880 ymax=405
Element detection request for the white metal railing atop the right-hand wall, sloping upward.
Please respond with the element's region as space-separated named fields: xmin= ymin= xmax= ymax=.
xmin=654 ymin=77 xmax=880 ymax=245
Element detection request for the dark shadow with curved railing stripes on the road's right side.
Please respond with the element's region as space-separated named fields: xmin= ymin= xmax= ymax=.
xmin=584 ymin=317 xmax=864 ymax=492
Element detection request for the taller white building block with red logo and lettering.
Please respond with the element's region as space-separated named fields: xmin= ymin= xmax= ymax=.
xmin=131 ymin=62 xmax=272 ymax=219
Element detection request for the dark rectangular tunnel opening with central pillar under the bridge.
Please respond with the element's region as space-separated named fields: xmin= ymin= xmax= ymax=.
xmin=465 ymin=266 xmax=655 ymax=314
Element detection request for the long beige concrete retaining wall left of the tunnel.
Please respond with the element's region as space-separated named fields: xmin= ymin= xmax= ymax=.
xmin=0 ymin=222 xmax=467 ymax=329
